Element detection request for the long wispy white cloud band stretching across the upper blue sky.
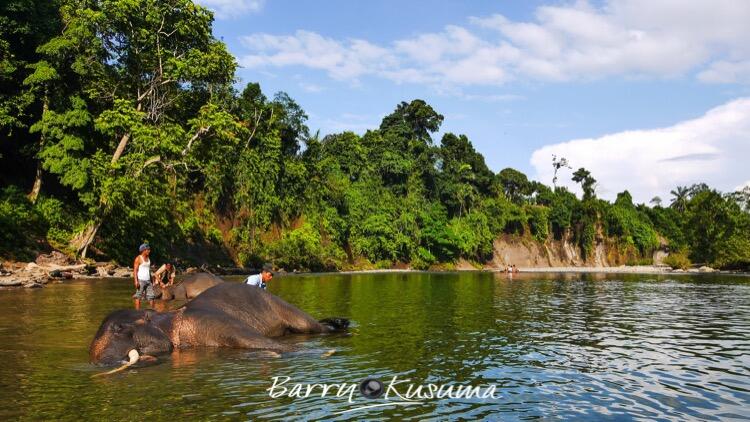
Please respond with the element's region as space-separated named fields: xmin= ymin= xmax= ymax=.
xmin=239 ymin=0 xmax=750 ymax=87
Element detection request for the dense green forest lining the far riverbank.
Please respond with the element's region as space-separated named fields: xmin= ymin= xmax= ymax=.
xmin=0 ymin=0 xmax=750 ymax=270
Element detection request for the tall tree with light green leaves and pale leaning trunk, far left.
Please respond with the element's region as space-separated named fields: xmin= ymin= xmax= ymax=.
xmin=35 ymin=0 xmax=235 ymax=256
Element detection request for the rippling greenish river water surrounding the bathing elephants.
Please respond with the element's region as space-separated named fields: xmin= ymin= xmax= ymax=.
xmin=0 ymin=273 xmax=750 ymax=420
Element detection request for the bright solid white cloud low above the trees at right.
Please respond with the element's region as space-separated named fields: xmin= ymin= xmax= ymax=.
xmin=531 ymin=98 xmax=750 ymax=202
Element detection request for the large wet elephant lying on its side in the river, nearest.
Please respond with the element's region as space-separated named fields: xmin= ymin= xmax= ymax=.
xmin=89 ymin=283 xmax=349 ymax=369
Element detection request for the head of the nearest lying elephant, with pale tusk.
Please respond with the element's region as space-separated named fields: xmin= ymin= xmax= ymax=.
xmin=89 ymin=310 xmax=172 ymax=365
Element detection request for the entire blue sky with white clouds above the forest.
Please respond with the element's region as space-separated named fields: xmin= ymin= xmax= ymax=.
xmin=197 ymin=0 xmax=750 ymax=203
